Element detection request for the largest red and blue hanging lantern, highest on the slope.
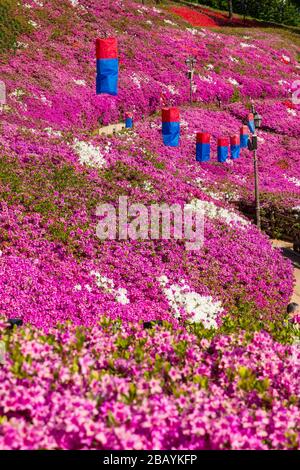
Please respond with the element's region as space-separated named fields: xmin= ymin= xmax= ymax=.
xmin=96 ymin=38 xmax=119 ymax=95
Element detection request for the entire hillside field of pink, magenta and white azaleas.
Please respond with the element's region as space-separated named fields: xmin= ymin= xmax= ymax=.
xmin=0 ymin=0 xmax=300 ymax=450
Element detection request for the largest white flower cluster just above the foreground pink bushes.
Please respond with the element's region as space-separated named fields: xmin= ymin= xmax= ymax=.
xmin=158 ymin=275 xmax=223 ymax=328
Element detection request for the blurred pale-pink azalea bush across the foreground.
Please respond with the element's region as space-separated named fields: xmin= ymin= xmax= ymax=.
xmin=0 ymin=319 xmax=300 ymax=450
